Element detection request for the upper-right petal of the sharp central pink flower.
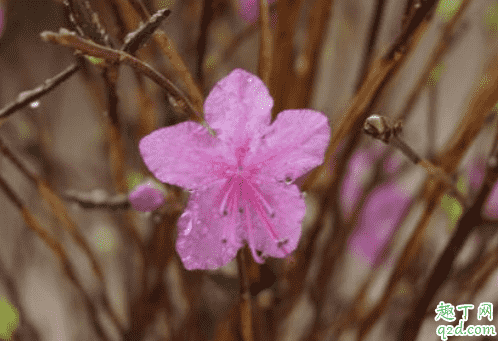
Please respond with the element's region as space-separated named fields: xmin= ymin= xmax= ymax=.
xmin=247 ymin=109 xmax=330 ymax=181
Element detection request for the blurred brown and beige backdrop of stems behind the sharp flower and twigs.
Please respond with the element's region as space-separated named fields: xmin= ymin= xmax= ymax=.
xmin=0 ymin=0 xmax=498 ymax=340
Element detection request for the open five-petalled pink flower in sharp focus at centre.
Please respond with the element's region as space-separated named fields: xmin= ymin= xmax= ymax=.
xmin=139 ymin=69 xmax=330 ymax=270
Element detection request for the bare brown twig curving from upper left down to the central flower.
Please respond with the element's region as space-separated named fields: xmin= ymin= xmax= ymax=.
xmin=41 ymin=28 xmax=202 ymax=122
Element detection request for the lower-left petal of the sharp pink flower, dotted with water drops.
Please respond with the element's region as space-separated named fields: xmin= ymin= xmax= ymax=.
xmin=176 ymin=181 xmax=242 ymax=270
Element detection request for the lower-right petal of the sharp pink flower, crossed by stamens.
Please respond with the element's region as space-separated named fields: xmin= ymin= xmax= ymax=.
xmin=242 ymin=179 xmax=306 ymax=258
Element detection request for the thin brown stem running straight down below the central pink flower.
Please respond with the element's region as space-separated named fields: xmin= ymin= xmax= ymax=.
xmin=237 ymin=250 xmax=254 ymax=341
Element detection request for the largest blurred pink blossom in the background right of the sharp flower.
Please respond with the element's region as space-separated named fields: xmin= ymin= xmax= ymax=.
xmin=349 ymin=184 xmax=410 ymax=265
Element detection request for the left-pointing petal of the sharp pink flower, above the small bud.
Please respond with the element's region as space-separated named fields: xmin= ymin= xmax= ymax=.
xmin=139 ymin=121 xmax=231 ymax=189
